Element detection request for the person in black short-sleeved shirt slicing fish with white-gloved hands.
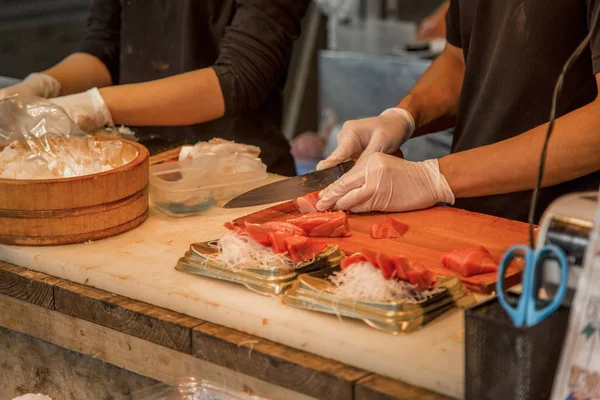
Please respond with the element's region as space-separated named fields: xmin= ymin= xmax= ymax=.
xmin=317 ymin=0 xmax=600 ymax=221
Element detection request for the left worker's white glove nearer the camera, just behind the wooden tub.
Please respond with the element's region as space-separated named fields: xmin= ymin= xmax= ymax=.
xmin=51 ymin=88 xmax=114 ymax=132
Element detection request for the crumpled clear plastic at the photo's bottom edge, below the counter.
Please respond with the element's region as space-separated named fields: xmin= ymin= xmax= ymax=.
xmin=130 ymin=378 xmax=266 ymax=400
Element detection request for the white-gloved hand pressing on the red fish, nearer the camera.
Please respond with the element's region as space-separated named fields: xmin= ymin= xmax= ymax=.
xmin=317 ymin=153 xmax=454 ymax=213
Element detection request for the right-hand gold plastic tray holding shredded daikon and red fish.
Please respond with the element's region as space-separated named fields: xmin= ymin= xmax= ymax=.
xmin=282 ymin=267 xmax=476 ymax=335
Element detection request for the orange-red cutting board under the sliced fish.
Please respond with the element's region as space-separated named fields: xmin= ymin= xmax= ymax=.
xmin=234 ymin=202 xmax=529 ymax=293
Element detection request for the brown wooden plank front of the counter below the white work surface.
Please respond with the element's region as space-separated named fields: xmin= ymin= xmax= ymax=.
xmin=0 ymin=262 xmax=448 ymax=400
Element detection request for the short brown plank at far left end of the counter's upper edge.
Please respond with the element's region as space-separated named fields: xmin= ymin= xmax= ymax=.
xmin=0 ymin=261 xmax=61 ymax=308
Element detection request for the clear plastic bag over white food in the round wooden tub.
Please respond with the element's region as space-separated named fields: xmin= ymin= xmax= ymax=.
xmin=0 ymin=96 xmax=127 ymax=179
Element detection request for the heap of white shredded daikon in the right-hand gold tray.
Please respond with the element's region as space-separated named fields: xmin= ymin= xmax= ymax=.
xmin=329 ymin=262 xmax=443 ymax=303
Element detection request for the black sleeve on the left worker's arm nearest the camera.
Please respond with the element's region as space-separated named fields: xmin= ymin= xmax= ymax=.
xmin=213 ymin=0 xmax=310 ymax=115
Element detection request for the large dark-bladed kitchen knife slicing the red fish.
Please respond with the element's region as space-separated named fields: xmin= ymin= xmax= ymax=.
xmin=223 ymin=161 xmax=354 ymax=208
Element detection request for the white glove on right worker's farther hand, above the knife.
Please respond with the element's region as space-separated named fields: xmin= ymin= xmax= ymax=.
xmin=317 ymin=108 xmax=415 ymax=170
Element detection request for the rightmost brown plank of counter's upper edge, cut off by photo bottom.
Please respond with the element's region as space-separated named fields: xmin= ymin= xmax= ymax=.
xmin=354 ymin=375 xmax=451 ymax=400
